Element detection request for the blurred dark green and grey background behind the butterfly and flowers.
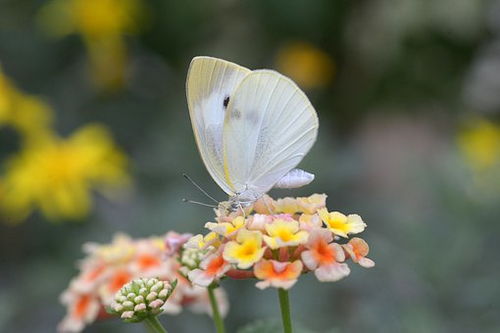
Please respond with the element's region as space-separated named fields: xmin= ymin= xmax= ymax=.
xmin=0 ymin=0 xmax=500 ymax=332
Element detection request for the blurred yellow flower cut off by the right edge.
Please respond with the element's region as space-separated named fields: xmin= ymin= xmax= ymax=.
xmin=458 ymin=120 xmax=500 ymax=173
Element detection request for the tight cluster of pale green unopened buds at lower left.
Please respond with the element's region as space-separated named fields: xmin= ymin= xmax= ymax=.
xmin=111 ymin=278 xmax=177 ymax=323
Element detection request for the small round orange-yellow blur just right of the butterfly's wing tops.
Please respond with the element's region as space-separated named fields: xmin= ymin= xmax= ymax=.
xmin=276 ymin=42 xmax=335 ymax=89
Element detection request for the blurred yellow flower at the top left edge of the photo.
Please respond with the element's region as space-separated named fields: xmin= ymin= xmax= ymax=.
xmin=39 ymin=0 xmax=143 ymax=90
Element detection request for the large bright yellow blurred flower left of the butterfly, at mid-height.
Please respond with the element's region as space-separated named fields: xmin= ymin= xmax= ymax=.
xmin=0 ymin=125 xmax=129 ymax=222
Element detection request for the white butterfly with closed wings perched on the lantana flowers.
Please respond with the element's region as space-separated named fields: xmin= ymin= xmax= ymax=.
xmin=186 ymin=57 xmax=318 ymax=206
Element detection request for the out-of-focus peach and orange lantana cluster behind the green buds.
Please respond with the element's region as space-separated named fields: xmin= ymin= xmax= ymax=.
xmin=58 ymin=232 xmax=228 ymax=332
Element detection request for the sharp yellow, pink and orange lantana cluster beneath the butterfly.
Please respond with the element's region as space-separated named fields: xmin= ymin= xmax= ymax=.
xmin=184 ymin=194 xmax=375 ymax=289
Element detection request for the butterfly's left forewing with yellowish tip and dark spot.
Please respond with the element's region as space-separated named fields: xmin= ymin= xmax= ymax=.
xmin=186 ymin=57 xmax=251 ymax=195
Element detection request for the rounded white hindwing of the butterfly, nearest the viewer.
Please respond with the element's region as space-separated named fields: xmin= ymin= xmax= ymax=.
xmin=223 ymin=70 xmax=318 ymax=196
